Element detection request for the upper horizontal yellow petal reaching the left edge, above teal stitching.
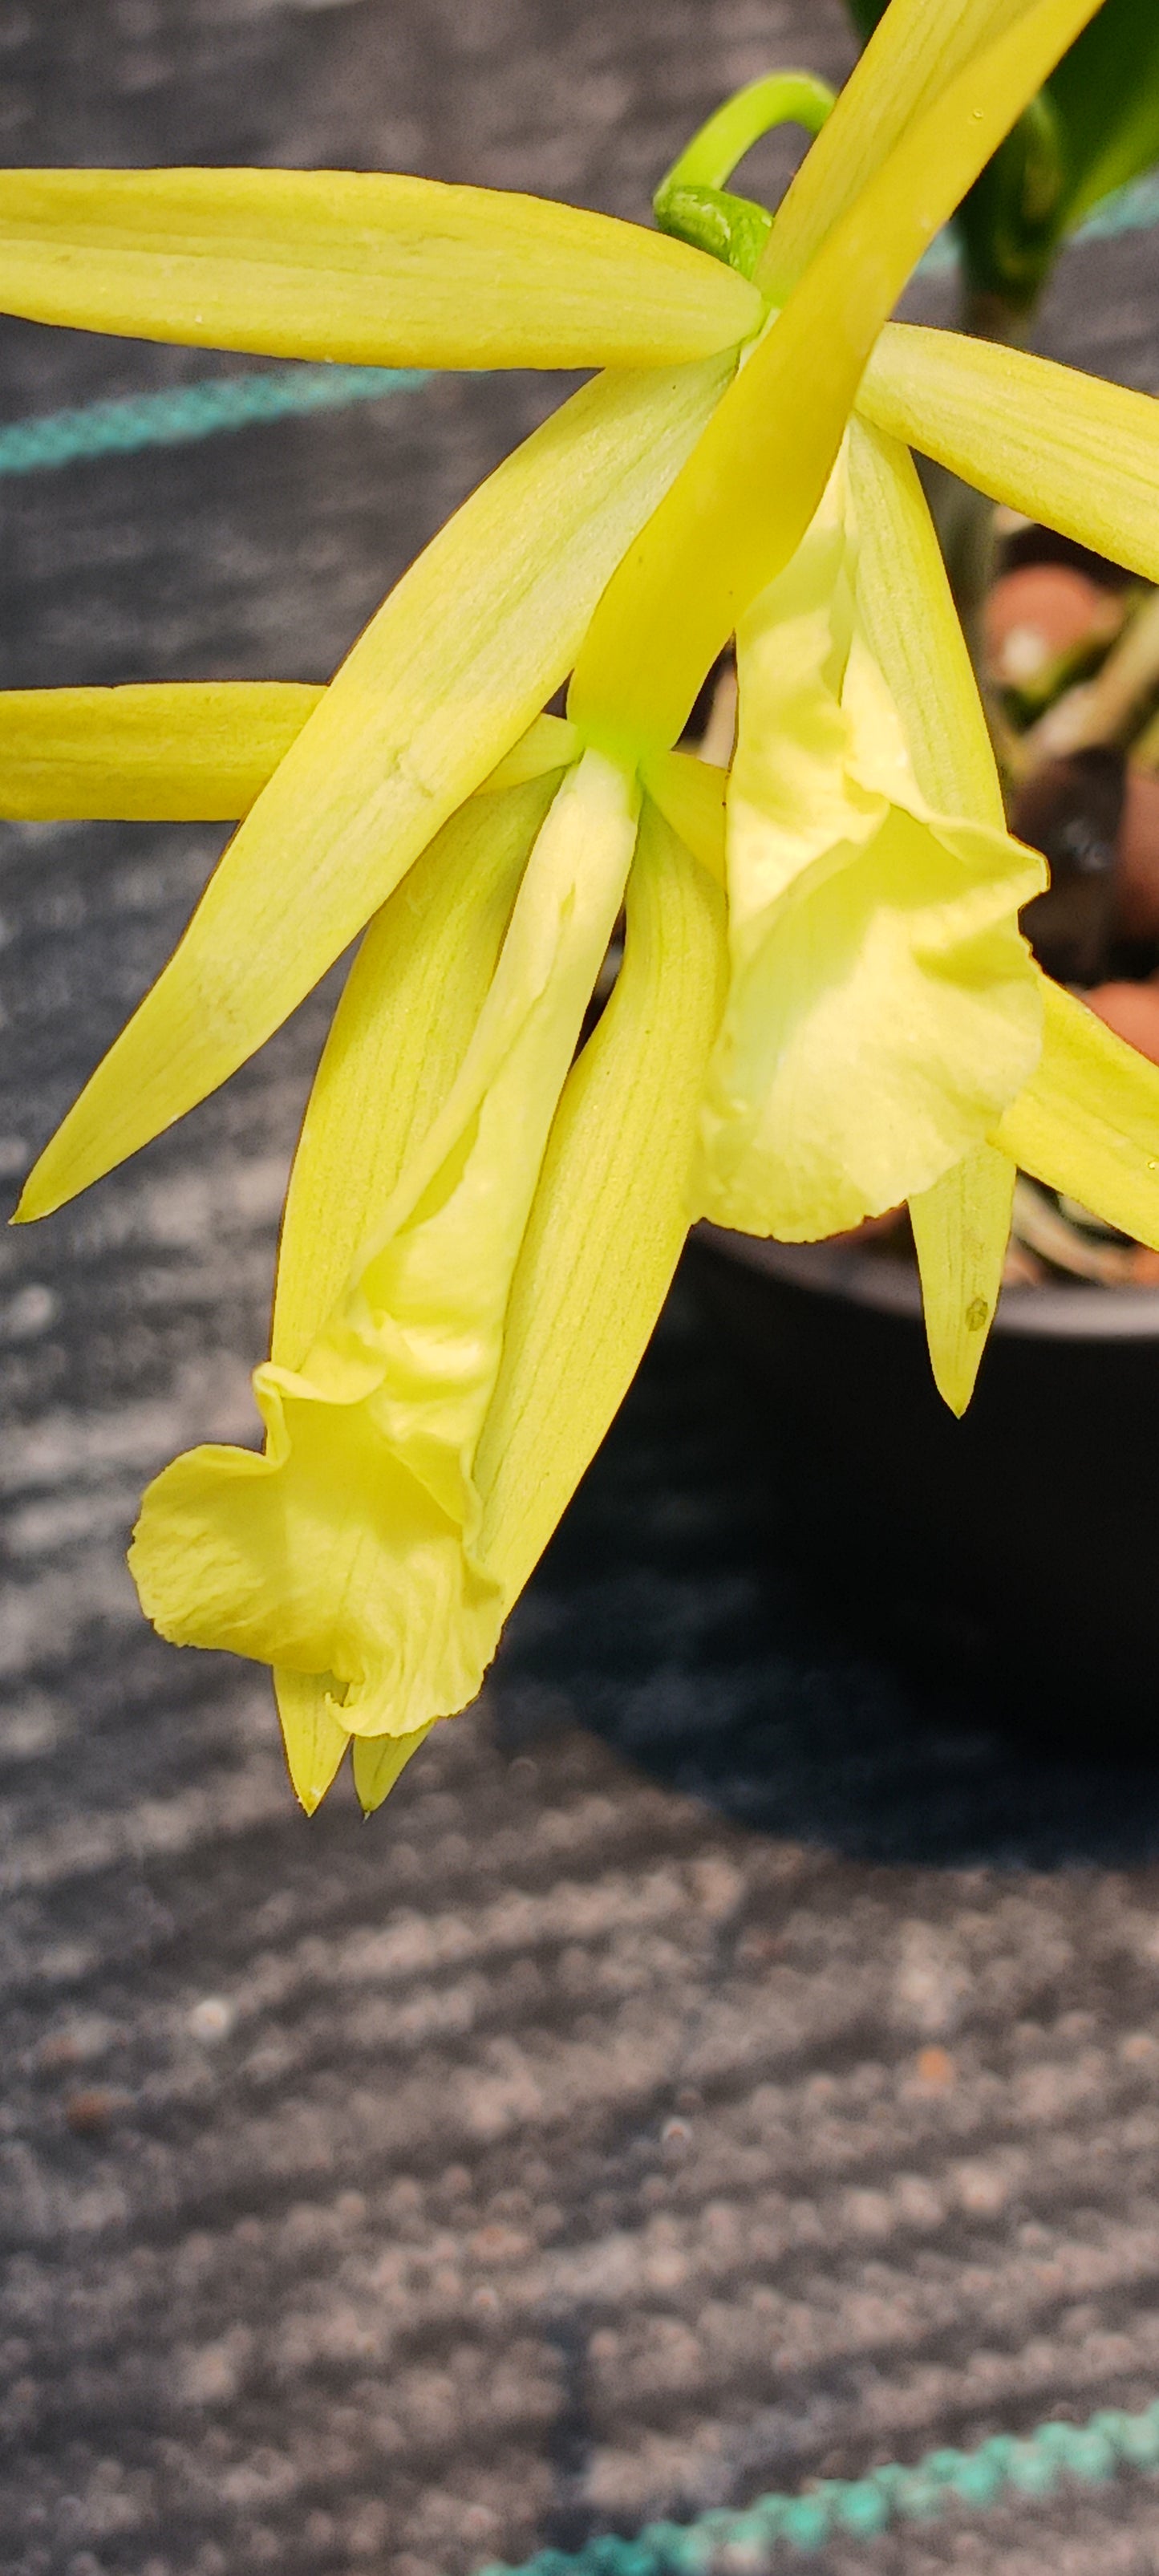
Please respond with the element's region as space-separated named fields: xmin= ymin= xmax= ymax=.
xmin=0 ymin=170 xmax=762 ymax=368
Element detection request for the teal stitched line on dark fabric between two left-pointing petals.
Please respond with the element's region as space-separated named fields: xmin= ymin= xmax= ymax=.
xmin=0 ymin=366 xmax=430 ymax=474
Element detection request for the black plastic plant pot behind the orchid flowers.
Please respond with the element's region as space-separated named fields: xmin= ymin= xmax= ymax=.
xmin=687 ymin=1226 xmax=1159 ymax=1736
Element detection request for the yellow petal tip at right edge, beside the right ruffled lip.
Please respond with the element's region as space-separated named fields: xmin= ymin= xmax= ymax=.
xmin=994 ymin=976 xmax=1159 ymax=1249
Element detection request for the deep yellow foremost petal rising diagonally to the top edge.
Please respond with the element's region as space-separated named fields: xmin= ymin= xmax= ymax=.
xmin=569 ymin=0 xmax=1100 ymax=747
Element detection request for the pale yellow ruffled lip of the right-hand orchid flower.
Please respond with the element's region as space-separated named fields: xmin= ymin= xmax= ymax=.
xmin=698 ymin=472 xmax=1046 ymax=1242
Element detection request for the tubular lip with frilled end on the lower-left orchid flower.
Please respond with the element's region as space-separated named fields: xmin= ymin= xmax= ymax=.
xmin=132 ymin=753 xmax=636 ymax=1736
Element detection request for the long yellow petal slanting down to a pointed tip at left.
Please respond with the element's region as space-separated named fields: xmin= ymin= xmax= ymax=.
xmin=21 ymin=358 xmax=731 ymax=1219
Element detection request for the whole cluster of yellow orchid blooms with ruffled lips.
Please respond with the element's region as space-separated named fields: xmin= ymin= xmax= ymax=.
xmin=0 ymin=0 xmax=1159 ymax=1808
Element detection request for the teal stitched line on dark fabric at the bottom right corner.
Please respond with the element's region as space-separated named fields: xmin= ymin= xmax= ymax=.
xmin=479 ymin=2404 xmax=1159 ymax=2576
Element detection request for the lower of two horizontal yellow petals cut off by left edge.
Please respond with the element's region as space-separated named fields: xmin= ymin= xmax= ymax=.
xmin=0 ymin=680 xmax=322 ymax=821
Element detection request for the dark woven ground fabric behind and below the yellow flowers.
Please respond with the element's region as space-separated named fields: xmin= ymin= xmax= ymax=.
xmin=11 ymin=0 xmax=1159 ymax=2576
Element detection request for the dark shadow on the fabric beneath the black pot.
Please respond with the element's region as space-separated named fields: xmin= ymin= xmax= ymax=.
xmin=495 ymin=1278 xmax=1159 ymax=1868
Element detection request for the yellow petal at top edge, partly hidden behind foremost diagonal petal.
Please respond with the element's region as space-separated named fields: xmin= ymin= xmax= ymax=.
xmin=760 ymin=0 xmax=1027 ymax=294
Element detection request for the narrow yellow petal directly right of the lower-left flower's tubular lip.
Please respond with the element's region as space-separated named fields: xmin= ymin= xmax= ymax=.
xmin=476 ymin=798 xmax=727 ymax=1604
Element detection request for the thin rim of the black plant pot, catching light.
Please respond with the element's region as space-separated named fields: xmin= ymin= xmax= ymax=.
xmin=693 ymin=1219 xmax=1159 ymax=1342
